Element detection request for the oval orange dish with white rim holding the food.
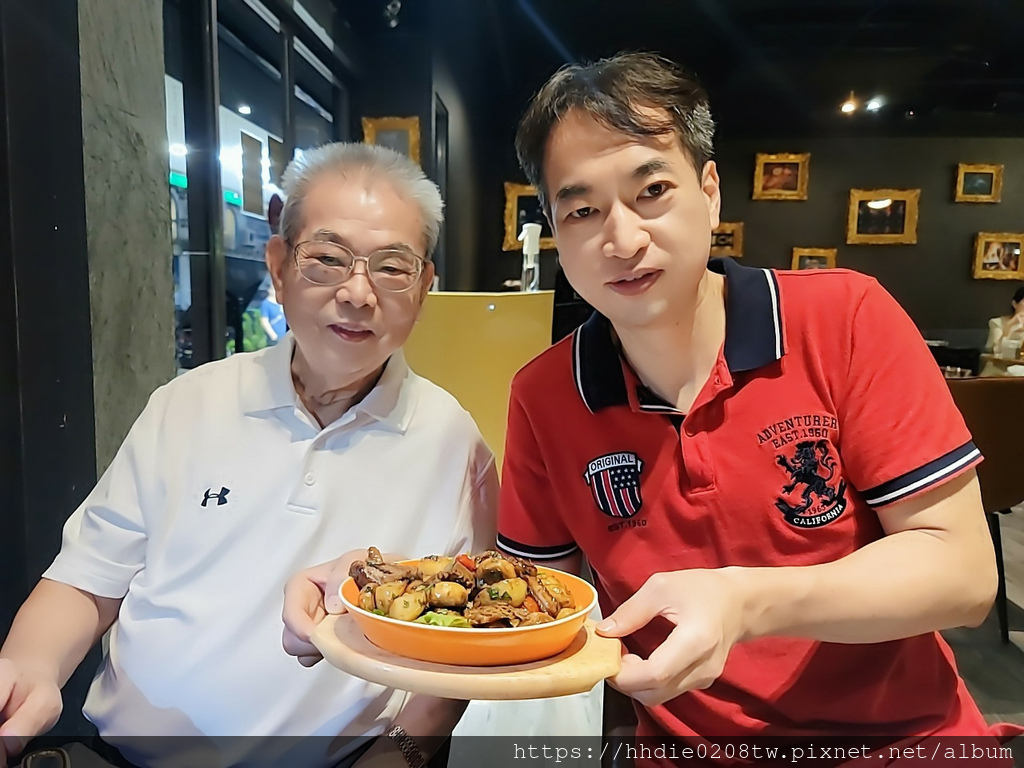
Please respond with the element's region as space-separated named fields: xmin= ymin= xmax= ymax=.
xmin=339 ymin=560 xmax=597 ymax=667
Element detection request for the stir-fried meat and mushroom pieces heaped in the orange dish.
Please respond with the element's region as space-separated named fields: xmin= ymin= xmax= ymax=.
xmin=348 ymin=547 xmax=582 ymax=629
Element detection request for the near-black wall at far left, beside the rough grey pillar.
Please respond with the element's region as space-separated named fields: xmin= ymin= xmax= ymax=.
xmin=0 ymin=0 xmax=102 ymax=735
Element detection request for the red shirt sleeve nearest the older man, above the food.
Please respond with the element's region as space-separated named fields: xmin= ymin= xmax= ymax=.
xmin=498 ymin=381 xmax=578 ymax=560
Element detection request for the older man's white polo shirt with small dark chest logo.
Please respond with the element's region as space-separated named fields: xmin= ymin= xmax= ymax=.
xmin=43 ymin=335 xmax=498 ymax=765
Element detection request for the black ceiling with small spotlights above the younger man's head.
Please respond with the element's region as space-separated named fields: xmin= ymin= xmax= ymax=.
xmin=337 ymin=0 xmax=1024 ymax=135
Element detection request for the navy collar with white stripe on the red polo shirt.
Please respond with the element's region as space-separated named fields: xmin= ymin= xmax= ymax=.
xmin=572 ymin=259 xmax=785 ymax=413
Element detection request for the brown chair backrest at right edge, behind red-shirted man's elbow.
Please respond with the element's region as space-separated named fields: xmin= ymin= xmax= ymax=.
xmin=946 ymin=376 xmax=1024 ymax=512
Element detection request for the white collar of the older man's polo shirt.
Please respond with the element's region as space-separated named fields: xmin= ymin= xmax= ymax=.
xmin=239 ymin=333 xmax=416 ymax=432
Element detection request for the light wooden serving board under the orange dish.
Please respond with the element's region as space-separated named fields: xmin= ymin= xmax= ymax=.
xmin=311 ymin=613 xmax=622 ymax=701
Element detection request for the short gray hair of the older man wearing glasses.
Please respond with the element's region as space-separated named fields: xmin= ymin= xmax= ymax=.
xmin=281 ymin=141 xmax=444 ymax=259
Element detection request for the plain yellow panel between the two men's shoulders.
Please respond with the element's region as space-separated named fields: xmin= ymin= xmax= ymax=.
xmin=406 ymin=291 xmax=554 ymax=471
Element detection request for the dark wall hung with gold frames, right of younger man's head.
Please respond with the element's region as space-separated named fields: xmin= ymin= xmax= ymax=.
xmin=717 ymin=138 xmax=1024 ymax=340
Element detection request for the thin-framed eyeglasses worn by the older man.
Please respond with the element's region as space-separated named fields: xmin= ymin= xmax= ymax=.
xmin=295 ymin=240 xmax=424 ymax=293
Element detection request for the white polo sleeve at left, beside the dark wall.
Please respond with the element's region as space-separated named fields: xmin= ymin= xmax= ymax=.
xmin=43 ymin=397 xmax=163 ymax=599
